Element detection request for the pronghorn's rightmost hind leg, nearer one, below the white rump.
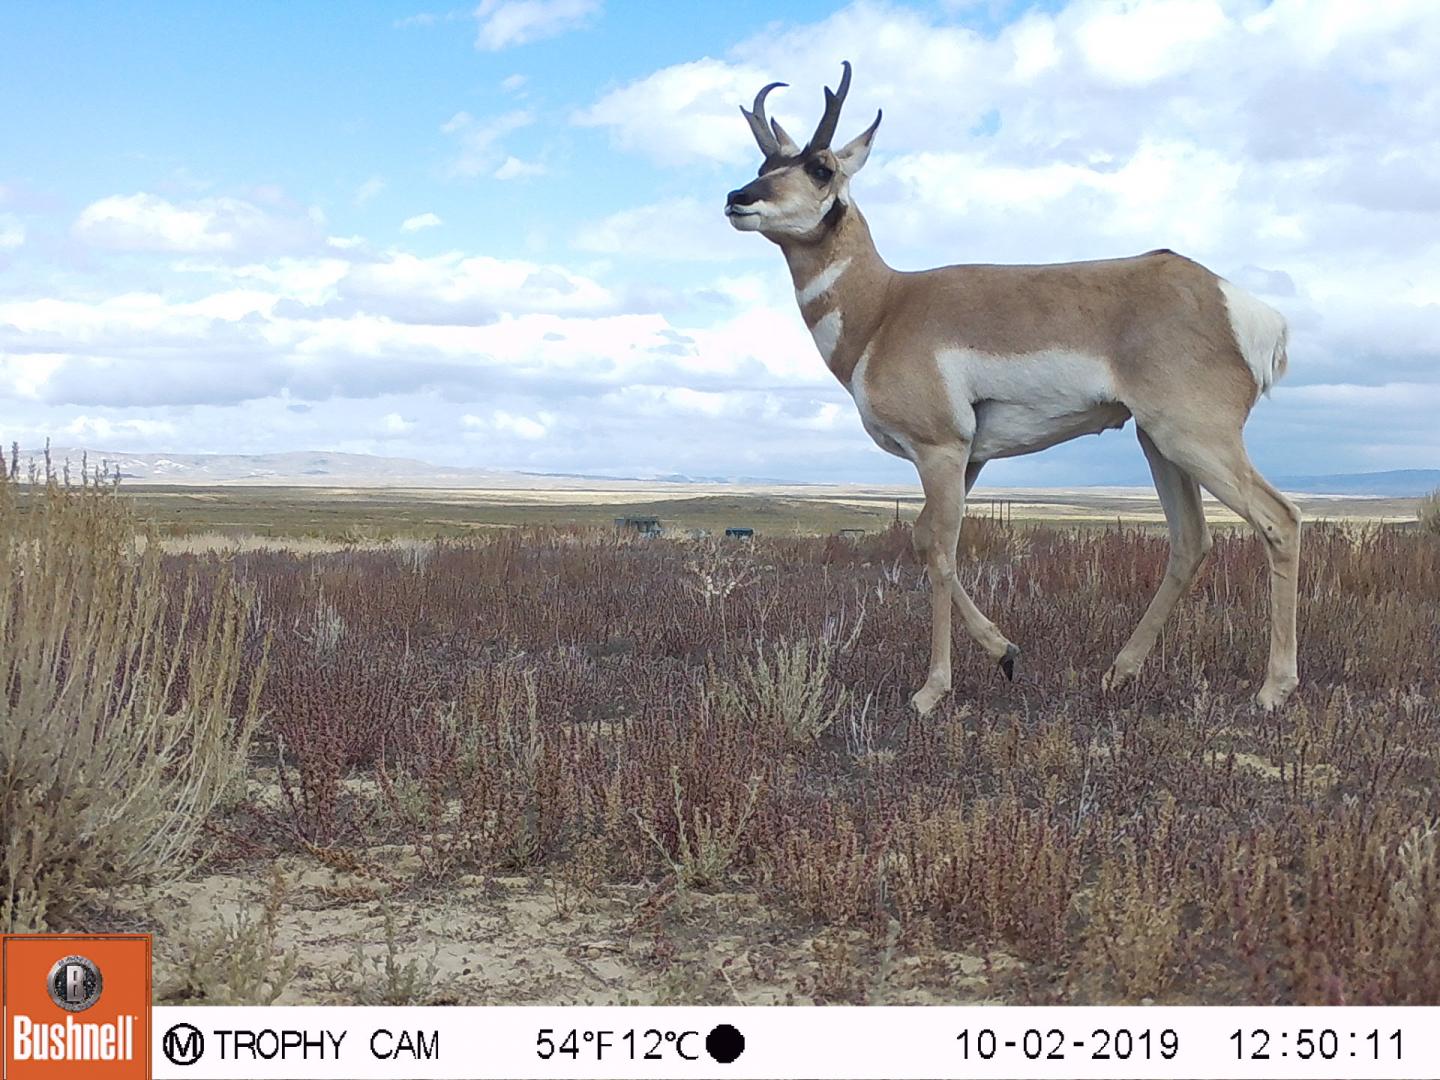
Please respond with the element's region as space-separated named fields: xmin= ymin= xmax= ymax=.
xmin=1152 ymin=429 xmax=1300 ymax=710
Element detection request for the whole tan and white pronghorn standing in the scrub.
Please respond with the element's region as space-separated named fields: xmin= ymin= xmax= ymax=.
xmin=724 ymin=62 xmax=1300 ymax=714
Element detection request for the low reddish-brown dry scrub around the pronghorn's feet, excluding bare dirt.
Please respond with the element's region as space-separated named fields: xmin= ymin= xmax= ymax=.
xmin=14 ymin=480 xmax=1440 ymax=1004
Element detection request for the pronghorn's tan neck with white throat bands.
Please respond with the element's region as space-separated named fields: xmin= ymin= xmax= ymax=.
xmin=780 ymin=202 xmax=894 ymax=386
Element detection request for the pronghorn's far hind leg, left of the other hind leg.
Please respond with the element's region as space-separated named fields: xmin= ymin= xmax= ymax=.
xmin=1102 ymin=428 xmax=1214 ymax=690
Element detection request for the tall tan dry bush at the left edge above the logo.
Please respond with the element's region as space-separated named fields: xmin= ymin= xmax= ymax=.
xmin=0 ymin=478 xmax=265 ymax=930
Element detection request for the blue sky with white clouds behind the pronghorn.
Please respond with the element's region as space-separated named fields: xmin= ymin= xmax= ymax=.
xmin=0 ymin=0 xmax=1440 ymax=484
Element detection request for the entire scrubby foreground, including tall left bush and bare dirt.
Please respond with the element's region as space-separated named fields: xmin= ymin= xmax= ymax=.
xmin=0 ymin=485 xmax=1440 ymax=1004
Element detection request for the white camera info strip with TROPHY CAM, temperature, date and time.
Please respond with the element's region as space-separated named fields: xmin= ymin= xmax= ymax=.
xmin=140 ymin=1005 xmax=1440 ymax=1080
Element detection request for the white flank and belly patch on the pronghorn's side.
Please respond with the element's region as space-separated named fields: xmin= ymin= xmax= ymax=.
xmin=935 ymin=348 xmax=1130 ymax=461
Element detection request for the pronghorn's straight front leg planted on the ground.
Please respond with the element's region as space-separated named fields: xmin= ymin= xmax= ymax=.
xmin=910 ymin=444 xmax=969 ymax=716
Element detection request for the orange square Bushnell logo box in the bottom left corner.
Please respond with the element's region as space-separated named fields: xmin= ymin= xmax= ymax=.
xmin=0 ymin=933 xmax=150 ymax=1080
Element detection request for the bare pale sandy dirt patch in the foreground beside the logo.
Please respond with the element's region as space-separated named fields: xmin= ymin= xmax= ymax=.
xmin=115 ymin=848 xmax=1021 ymax=1005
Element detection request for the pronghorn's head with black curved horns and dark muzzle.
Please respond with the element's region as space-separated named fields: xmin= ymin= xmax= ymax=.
xmin=724 ymin=60 xmax=880 ymax=243
